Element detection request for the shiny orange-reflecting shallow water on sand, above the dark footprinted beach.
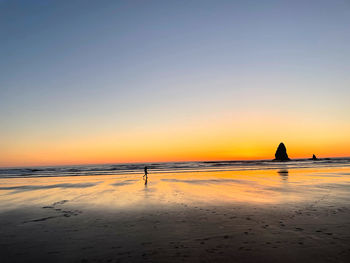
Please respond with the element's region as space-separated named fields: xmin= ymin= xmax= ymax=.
xmin=0 ymin=167 xmax=350 ymax=212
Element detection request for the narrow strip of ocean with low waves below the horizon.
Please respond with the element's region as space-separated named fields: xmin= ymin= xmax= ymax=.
xmin=0 ymin=158 xmax=350 ymax=178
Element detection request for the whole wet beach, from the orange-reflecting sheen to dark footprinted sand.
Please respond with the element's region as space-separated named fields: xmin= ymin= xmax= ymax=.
xmin=0 ymin=168 xmax=350 ymax=262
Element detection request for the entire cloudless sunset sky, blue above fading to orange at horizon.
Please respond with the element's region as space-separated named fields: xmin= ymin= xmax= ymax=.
xmin=0 ymin=0 xmax=350 ymax=167
